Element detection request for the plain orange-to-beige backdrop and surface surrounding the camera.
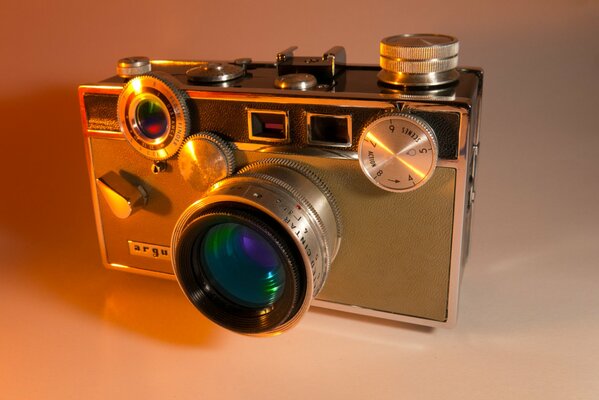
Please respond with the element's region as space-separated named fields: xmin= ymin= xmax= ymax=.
xmin=0 ymin=0 xmax=599 ymax=399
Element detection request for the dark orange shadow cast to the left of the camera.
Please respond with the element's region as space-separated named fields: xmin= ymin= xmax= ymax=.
xmin=0 ymin=87 xmax=219 ymax=346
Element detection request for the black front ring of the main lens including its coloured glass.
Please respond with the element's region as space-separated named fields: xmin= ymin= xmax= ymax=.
xmin=175 ymin=203 xmax=308 ymax=335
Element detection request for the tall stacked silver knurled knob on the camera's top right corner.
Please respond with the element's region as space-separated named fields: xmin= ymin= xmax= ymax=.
xmin=378 ymin=33 xmax=459 ymax=86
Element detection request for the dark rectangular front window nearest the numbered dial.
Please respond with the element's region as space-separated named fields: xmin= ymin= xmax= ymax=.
xmin=307 ymin=113 xmax=351 ymax=147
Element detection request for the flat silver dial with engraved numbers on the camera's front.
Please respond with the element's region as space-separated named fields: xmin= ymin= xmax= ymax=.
xmin=358 ymin=113 xmax=438 ymax=192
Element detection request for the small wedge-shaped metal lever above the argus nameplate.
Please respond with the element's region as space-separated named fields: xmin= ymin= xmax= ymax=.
xmin=96 ymin=171 xmax=148 ymax=219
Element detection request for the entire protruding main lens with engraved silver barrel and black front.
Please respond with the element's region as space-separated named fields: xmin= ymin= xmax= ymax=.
xmin=172 ymin=159 xmax=341 ymax=335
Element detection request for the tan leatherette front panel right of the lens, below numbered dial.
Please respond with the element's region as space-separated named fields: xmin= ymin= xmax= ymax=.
xmin=240 ymin=153 xmax=456 ymax=321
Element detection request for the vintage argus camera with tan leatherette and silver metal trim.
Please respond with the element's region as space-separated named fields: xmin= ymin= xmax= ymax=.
xmin=79 ymin=34 xmax=482 ymax=335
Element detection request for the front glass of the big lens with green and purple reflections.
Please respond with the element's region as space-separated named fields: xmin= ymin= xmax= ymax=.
xmin=199 ymin=222 xmax=286 ymax=308
